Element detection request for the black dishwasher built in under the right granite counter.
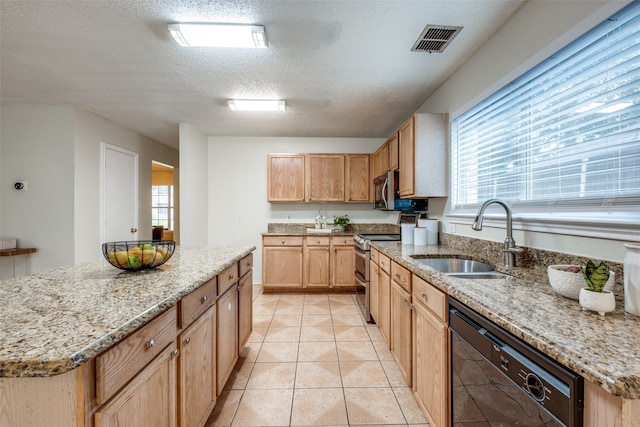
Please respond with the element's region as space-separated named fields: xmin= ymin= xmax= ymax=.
xmin=449 ymin=297 xmax=584 ymax=427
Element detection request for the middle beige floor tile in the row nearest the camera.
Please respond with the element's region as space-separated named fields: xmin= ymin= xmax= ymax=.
xmin=291 ymin=388 xmax=348 ymax=426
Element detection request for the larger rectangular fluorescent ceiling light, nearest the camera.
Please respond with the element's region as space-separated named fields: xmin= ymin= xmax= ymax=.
xmin=169 ymin=24 xmax=267 ymax=48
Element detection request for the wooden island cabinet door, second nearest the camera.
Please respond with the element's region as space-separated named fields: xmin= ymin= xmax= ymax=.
xmin=178 ymin=306 xmax=216 ymax=427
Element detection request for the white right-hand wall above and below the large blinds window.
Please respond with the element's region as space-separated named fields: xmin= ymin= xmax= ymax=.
xmin=418 ymin=0 xmax=629 ymax=262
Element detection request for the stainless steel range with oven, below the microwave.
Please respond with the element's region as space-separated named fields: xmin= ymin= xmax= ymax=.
xmin=353 ymin=233 xmax=400 ymax=323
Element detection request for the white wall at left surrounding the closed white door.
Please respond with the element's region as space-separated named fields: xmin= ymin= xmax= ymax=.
xmin=0 ymin=105 xmax=179 ymax=278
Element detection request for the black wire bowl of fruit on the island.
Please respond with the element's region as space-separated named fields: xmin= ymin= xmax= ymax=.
xmin=102 ymin=240 xmax=176 ymax=271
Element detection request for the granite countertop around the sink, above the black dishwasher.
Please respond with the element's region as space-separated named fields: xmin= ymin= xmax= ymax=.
xmin=371 ymin=242 xmax=640 ymax=399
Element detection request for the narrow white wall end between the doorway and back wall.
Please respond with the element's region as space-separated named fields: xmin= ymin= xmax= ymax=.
xmin=179 ymin=123 xmax=209 ymax=246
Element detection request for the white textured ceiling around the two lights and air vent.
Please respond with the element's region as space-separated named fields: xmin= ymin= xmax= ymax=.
xmin=0 ymin=0 xmax=524 ymax=148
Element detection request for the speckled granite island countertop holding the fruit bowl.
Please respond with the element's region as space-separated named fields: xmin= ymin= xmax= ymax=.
xmin=0 ymin=246 xmax=255 ymax=377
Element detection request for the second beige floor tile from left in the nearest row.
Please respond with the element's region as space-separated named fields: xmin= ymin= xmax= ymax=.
xmin=232 ymin=389 xmax=293 ymax=427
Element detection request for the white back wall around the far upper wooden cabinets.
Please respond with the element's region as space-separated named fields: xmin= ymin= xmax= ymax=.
xmin=208 ymin=137 xmax=396 ymax=283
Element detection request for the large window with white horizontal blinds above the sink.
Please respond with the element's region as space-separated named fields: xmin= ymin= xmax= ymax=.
xmin=451 ymin=3 xmax=640 ymax=218
